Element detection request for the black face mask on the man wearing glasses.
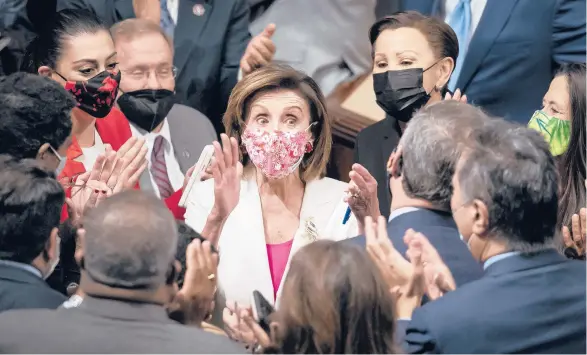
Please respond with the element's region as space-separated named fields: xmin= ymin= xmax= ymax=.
xmin=118 ymin=89 xmax=177 ymax=132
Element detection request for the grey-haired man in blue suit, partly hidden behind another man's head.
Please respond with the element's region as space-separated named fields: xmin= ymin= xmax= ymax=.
xmin=344 ymin=100 xmax=488 ymax=285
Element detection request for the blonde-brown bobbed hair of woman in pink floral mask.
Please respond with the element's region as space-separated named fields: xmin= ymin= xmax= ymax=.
xmin=223 ymin=64 xmax=332 ymax=182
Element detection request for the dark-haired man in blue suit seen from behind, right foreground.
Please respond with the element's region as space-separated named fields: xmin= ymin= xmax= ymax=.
xmin=398 ymin=120 xmax=586 ymax=354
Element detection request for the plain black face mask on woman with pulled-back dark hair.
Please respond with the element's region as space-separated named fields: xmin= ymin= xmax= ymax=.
xmin=373 ymin=64 xmax=434 ymax=122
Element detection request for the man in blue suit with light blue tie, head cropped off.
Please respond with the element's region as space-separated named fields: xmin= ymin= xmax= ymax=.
xmin=400 ymin=0 xmax=585 ymax=124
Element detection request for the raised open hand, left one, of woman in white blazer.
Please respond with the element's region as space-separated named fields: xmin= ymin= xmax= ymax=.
xmin=210 ymin=133 xmax=243 ymax=220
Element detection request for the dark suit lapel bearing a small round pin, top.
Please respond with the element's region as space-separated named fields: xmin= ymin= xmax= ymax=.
xmin=173 ymin=0 xmax=212 ymax=76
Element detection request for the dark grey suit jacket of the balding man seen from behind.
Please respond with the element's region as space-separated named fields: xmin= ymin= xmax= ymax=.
xmin=0 ymin=296 xmax=244 ymax=354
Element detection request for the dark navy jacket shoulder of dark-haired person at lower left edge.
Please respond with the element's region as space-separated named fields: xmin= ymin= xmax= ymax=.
xmin=0 ymin=264 xmax=67 ymax=312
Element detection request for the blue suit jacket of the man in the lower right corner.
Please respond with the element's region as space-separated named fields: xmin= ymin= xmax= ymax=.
xmin=399 ymin=250 xmax=586 ymax=354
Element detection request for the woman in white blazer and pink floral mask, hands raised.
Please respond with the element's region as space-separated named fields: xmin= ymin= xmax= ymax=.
xmin=185 ymin=65 xmax=378 ymax=330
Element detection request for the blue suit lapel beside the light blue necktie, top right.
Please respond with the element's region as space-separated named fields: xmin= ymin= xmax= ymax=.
xmin=457 ymin=0 xmax=518 ymax=91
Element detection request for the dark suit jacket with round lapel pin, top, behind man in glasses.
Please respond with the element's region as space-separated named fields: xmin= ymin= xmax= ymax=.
xmin=57 ymin=0 xmax=251 ymax=132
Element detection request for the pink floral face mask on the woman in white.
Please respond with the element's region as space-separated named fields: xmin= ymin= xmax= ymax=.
xmin=242 ymin=123 xmax=314 ymax=179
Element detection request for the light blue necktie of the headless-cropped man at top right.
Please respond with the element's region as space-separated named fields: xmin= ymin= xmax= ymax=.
xmin=448 ymin=0 xmax=471 ymax=92
